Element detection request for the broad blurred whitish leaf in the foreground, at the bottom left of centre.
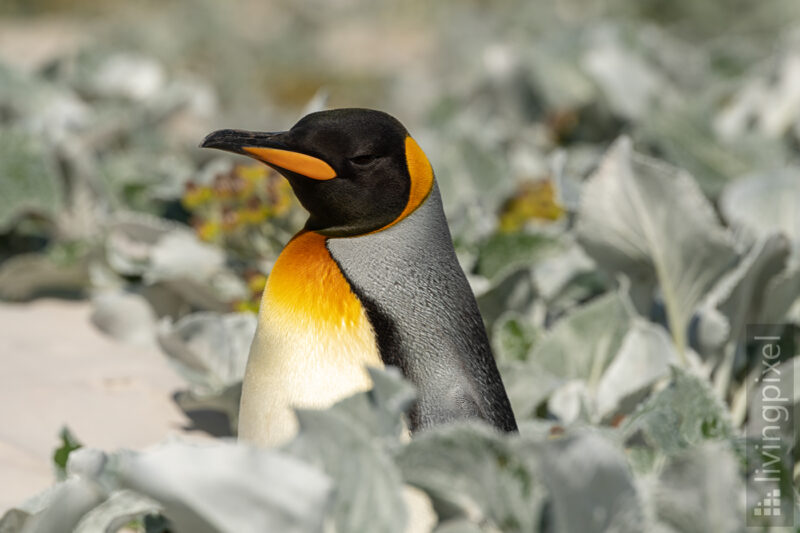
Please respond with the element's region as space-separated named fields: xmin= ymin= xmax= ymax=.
xmin=110 ymin=442 xmax=330 ymax=533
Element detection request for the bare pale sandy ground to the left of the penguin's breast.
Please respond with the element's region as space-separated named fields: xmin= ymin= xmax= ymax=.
xmin=0 ymin=299 xmax=195 ymax=515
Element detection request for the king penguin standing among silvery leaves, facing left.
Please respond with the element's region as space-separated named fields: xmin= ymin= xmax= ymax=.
xmin=201 ymin=109 xmax=517 ymax=446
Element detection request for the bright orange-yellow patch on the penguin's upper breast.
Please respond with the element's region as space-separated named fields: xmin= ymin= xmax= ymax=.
xmin=264 ymin=231 xmax=366 ymax=328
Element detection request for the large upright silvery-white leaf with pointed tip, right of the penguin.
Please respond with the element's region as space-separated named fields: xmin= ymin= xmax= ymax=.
xmin=578 ymin=137 xmax=736 ymax=352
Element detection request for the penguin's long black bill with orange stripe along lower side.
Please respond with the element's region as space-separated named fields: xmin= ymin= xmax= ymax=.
xmin=200 ymin=130 xmax=336 ymax=180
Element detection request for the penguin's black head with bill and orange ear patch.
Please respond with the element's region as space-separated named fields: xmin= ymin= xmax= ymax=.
xmin=200 ymin=109 xmax=433 ymax=237
